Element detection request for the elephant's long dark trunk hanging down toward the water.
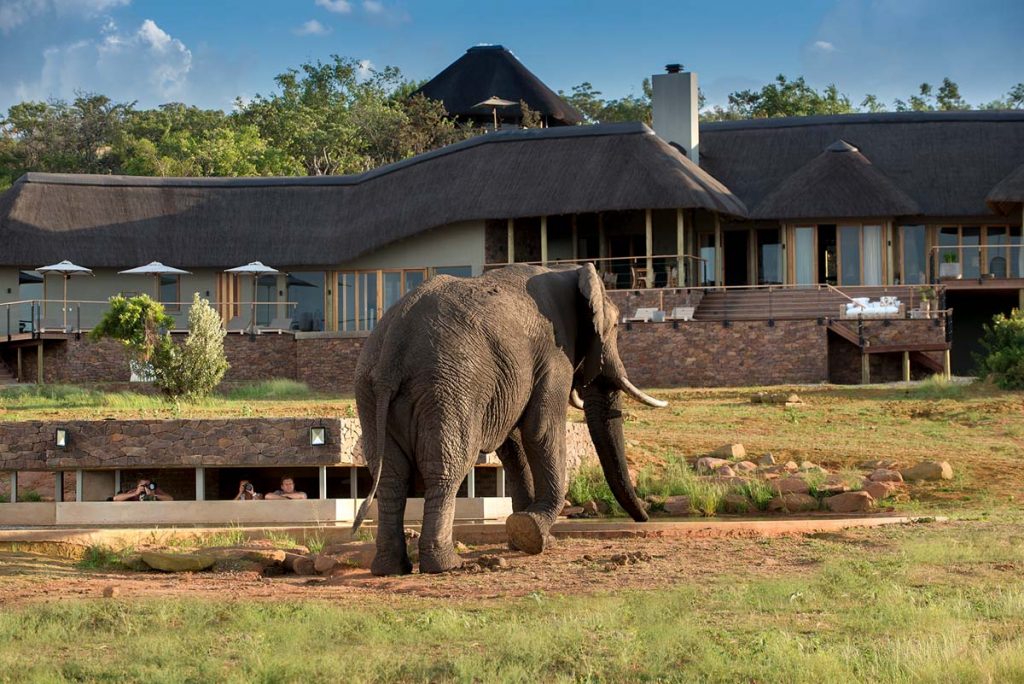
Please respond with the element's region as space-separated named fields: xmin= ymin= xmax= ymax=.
xmin=584 ymin=382 xmax=647 ymax=522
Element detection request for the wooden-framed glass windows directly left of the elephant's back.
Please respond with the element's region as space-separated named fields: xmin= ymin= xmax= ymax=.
xmin=338 ymin=266 xmax=428 ymax=332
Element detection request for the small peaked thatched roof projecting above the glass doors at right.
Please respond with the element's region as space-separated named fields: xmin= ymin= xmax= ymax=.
xmin=751 ymin=140 xmax=921 ymax=220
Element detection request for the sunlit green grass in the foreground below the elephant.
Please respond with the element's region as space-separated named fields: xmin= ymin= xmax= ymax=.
xmin=0 ymin=523 xmax=1024 ymax=683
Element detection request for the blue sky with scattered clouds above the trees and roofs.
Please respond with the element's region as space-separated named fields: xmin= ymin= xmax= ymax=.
xmin=0 ymin=0 xmax=1024 ymax=113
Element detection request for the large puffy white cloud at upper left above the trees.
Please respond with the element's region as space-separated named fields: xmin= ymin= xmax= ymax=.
xmin=15 ymin=19 xmax=193 ymax=102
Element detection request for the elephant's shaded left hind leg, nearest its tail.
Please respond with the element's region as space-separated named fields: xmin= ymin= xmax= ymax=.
xmin=370 ymin=437 xmax=413 ymax=575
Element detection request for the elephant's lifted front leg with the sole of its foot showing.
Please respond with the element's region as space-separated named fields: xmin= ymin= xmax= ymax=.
xmin=505 ymin=369 xmax=571 ymax=553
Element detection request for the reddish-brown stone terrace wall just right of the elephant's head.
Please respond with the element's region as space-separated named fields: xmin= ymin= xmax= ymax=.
xmin=618 ymin=320 xmax=831 ymax=387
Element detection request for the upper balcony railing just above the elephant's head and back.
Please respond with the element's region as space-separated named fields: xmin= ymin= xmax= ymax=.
xmin=483 ymin=254 xmax=715 ymax=290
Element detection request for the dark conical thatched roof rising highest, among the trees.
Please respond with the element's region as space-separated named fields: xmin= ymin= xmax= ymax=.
xmin=416 ymin=45 xmax=583 ymax=125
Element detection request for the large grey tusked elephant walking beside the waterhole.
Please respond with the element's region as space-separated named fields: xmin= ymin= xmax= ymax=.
xmin=352 ymin=264 xmax=666 ymax=575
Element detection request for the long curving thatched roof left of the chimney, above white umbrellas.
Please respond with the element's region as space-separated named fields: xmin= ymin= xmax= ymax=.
xmin=0 ymin=124 xmax=746 ymax=268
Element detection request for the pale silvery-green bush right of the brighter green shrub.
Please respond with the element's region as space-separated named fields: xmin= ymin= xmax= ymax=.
xmin=153 ymin=293 xmax=228 ymax=401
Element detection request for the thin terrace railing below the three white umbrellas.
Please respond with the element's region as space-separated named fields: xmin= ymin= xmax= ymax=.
xmin=0 ymin=299 xmax=301 ymax=341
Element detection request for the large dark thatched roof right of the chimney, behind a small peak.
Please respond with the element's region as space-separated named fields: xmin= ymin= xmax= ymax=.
xmin=700 ymin=112 xmax=1024 ymax=216
